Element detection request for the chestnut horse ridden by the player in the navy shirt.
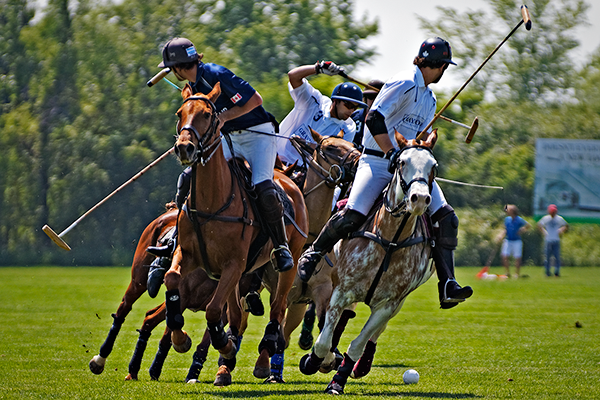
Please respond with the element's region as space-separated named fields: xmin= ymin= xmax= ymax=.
xmin=164 ymin=83 xmax=308 ymax=376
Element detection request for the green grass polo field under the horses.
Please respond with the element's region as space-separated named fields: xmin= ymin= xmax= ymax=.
xmin=0 ymin=267 xmax=600 ymax=400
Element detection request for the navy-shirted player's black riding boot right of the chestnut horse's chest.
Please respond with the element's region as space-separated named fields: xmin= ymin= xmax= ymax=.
xmin=256 ymin=180 xmax=294 ymax=272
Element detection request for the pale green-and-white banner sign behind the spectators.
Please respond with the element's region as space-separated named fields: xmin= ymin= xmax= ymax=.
xmin=533 ymin=139 xmax=600 ymax=222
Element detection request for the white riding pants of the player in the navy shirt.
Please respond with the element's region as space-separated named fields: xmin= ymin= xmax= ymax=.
xmin=223 ymin=122 xmax=277 ymax=185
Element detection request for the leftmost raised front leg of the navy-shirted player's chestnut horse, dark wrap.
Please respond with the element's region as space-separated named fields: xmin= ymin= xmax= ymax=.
xmin=164 ymin=247 xmax=192 ymax=353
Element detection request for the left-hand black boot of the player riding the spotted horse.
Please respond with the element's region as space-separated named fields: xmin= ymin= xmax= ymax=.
xmin=298 ymin=208 xmax=367 ymax=282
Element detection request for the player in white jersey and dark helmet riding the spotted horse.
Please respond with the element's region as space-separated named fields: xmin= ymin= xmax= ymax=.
xmin=298 ymin=38 xmax=473 ymax=309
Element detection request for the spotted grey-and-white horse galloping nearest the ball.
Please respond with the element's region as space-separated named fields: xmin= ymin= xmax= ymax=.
xmin=300 ymin=131 xmax=437 ymax=394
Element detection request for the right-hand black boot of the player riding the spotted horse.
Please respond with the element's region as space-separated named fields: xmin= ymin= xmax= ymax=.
xmin=431 ymin=205 xmax=473 ymax=309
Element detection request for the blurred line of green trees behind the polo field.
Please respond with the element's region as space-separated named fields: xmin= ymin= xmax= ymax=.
xmin=0 ymin=0 xmax=600 ymax=265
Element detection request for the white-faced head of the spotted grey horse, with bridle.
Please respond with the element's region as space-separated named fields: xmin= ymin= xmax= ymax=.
xmin=385 ymin=130 xmax=437 ymax=215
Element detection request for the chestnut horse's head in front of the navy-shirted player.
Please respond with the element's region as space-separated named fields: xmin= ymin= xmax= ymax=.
xmin=175 ymin=82 xmax=221 ymax=165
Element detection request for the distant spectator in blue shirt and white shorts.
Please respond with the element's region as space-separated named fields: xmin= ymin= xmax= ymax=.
xmin=500 ymin=204 xmax=530 ymax=278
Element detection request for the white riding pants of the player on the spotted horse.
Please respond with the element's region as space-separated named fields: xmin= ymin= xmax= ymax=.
xmin=346 ymin=154 xmax=448 ymax=215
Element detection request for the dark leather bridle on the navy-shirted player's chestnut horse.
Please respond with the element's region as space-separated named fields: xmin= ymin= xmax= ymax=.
xmin=175 ymin=96 xmax=222 ymax=166
